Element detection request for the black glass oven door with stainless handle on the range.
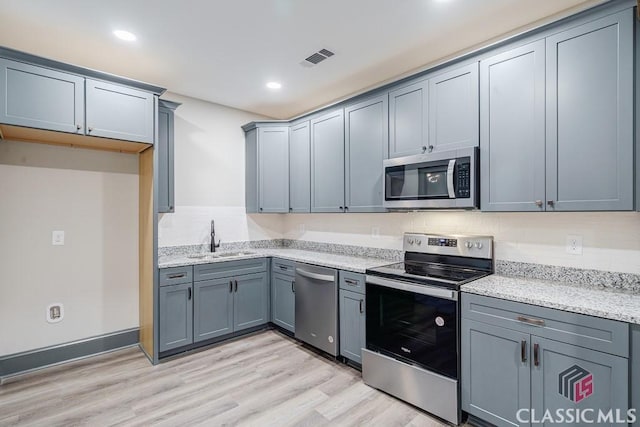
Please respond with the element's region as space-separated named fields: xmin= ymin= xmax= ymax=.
xmin=366 ymin=275 xmax=459 ymax=379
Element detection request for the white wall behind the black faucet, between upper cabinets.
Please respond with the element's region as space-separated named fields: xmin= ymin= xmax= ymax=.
xmin=158 ymin=93 xmax=284 ymax=247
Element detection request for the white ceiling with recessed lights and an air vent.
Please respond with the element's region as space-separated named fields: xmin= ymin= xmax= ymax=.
xmin=0 ymin=0 xmax=604 ymax=118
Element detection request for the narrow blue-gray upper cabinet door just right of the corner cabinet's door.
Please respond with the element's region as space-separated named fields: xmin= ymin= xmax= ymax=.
xmin=289 ymin=121 xmax=311 ymax=213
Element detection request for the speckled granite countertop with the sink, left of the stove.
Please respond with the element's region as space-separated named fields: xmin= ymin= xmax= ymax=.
xmin=158 ymin=248 xmax=393 ymax=273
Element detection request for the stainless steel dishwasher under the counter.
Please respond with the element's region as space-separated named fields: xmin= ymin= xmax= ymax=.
xmin=295 ymin=264 xmax=339 ymax=356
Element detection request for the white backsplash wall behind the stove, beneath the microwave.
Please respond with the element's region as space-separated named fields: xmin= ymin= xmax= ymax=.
xmin=283 ymin=211 xmax=640 ymax=274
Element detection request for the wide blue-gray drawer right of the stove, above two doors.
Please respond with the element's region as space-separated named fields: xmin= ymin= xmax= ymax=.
xmin=462 ymin=293 xmax=629 ymax=357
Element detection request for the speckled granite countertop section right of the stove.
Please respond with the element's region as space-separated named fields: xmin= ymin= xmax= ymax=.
xmin=462 ymin=274 xmax=640 ymax=324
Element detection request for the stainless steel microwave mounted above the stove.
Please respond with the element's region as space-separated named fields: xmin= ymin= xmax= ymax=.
xmin=383 ymin=147 xmax=480 ymax=209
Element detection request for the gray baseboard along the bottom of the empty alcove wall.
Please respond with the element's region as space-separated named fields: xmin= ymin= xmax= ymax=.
xmin=0 ymin=328 xmax=140 ymax=379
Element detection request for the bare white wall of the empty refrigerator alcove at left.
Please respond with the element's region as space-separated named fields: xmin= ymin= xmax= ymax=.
xmin=0 ymin=141 xmax=138 ymax=356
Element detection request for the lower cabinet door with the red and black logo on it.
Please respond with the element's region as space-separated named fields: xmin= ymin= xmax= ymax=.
xmin=531 ymin=336 xmax=629 ymax=425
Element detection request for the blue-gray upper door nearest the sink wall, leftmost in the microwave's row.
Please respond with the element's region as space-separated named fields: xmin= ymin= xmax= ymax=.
xmin=258 ymin=126 xmax=289 ymax=213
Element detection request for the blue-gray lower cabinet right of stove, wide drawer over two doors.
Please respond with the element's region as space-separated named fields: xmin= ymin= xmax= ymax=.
xmin=461 ymin=293 xmax=629 ymax=426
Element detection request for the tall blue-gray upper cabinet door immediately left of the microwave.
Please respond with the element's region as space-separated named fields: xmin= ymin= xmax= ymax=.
xmin=344 ymin=94 xmax=389 ymax=212
